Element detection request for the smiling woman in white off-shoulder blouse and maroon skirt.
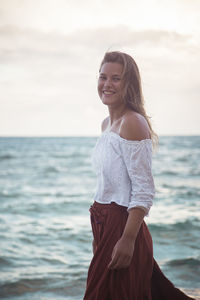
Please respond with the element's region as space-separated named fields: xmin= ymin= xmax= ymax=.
xmin=84 ymin=52 xmax=192 ymax=300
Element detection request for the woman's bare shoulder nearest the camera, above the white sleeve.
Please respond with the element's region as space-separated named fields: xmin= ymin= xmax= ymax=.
xmin=119 ymin=111 xmax=151 ymax=141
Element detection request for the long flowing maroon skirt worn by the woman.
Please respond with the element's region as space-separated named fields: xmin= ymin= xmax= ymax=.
xmin=83 ymin=202 xmax=193 ymax=300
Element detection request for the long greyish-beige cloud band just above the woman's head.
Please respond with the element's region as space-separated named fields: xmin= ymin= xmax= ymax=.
xmin=0 ymin=25 xmax=195 ymax=56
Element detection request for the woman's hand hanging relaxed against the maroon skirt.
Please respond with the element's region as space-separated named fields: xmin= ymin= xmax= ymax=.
xmin=108 ymin=237 xmax=135 ymax=269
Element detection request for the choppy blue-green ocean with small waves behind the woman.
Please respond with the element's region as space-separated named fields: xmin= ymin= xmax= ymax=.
xmin=0 ymin=136 xmax=200 ymax=300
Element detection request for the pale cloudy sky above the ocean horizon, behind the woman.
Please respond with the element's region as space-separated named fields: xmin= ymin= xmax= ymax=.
xmin=0 ymin=0 xmax=200 ymax=136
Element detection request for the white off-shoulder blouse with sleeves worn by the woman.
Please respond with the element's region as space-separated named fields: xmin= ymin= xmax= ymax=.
xmin=91 ymin=131 xmax=155 ymax=215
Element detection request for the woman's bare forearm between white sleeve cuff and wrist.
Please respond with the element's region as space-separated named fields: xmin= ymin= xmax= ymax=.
xmin=122 ymin=207 xmax=145 ymax=241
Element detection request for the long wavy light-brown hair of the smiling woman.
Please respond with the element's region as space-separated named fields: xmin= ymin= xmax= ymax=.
xmin=100 ymin=51 xmax=158 ymax=148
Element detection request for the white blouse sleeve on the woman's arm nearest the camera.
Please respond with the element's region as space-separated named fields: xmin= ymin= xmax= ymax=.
xmin=121 ymin=139 xmax=155 ymax=216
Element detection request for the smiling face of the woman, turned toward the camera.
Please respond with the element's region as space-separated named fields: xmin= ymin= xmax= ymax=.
xmin=98 ymin=62 xmax=123 ymax=105
